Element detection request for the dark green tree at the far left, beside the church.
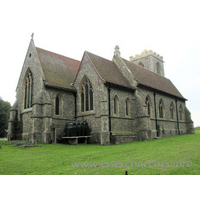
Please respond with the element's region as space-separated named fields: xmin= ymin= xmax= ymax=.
xmin=0 ymin=97 xmax=11 ymax=138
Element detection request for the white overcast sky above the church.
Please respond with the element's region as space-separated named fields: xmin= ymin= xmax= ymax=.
xmin=0 ymin=0 xmax=200 ymax=126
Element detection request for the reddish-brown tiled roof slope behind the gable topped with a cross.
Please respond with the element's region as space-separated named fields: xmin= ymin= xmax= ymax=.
xmin=36 ymin=47 xmax=80 ymax=90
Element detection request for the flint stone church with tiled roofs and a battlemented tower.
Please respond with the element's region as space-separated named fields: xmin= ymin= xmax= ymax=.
xmin=8 ymin=39 xmax=194 ymax=145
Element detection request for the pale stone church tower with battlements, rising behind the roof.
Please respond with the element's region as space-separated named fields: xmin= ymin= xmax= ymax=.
xmin=130 ymin=49 xmax=165 ymax=76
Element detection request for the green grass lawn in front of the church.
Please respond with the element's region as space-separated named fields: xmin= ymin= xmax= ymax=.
xmin=0 ymin=129 xmax=200 ymax=175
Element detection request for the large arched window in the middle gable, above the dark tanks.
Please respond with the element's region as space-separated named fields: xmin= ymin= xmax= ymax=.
xmin=81 ymin=78 xmax=93 ymax=112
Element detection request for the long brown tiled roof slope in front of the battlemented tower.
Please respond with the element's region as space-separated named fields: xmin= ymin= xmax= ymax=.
xmin=123 ymin=59 xmax=185 ymax=99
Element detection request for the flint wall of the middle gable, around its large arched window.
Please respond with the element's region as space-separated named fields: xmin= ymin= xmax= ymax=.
xmin=74 ymin=55 xmax=108 ymax=143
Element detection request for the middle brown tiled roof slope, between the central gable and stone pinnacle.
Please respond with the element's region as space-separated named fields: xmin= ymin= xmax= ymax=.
xmin=86 ymin=52 xmax=132 ymax=88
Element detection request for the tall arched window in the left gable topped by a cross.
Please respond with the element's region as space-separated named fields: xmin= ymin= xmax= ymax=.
xmin=24 ymin=70 xmax=33 ymax=109
